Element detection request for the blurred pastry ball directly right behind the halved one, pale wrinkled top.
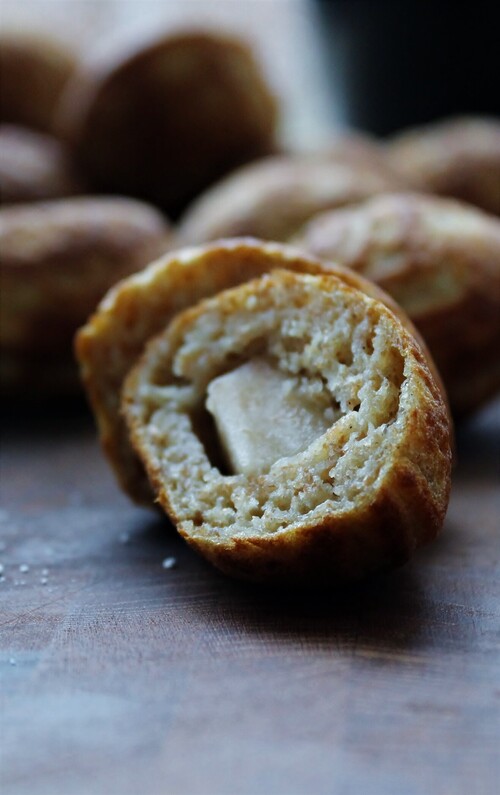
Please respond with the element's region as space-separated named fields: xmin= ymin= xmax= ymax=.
xmin=296 ymin=194 xmax=500 ymax=416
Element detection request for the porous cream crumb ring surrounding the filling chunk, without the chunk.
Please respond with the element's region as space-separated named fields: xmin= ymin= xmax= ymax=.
xmin=129 ymin=274 xmax=411 ymax=538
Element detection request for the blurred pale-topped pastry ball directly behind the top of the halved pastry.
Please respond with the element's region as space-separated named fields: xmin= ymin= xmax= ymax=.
xmin=179 ymin=153 xmax=401 ymax=245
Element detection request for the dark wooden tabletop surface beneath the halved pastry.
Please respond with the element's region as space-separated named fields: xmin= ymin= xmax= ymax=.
xmin=0 ymin=404 xmax=500 ymax=795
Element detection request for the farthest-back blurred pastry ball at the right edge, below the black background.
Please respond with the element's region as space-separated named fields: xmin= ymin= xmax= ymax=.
xmin=388 ymin=118 xmax=500 ymax=215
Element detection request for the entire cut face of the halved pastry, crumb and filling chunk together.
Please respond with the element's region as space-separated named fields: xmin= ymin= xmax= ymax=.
xmin=134 ymin=277 xmax=406 ymax=538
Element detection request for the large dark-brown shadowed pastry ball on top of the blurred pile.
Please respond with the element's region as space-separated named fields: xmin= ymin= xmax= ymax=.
xmin=59 ymin=32 xmax=277 ymax=214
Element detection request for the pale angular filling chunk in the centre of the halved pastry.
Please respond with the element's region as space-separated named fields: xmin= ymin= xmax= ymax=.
xmin=205 ymin=358 xmax=335 ymax=475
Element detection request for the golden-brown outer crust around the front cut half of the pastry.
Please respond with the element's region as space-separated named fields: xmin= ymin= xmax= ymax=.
xmin=124 ymin=272 xmax=451 ymax=585
